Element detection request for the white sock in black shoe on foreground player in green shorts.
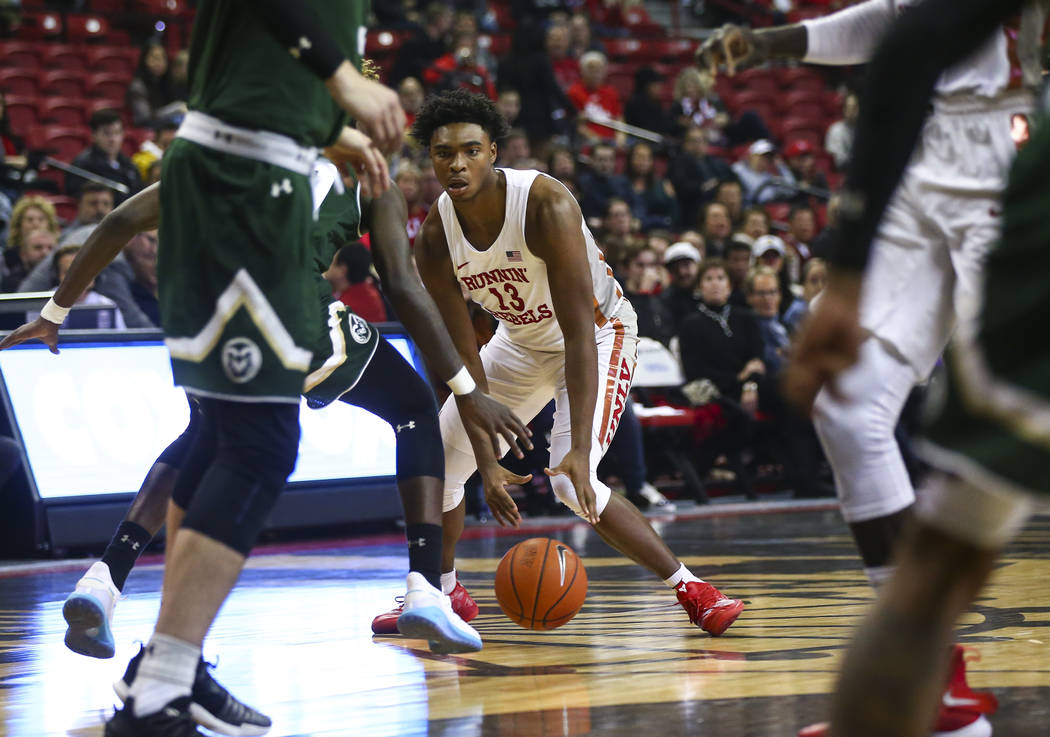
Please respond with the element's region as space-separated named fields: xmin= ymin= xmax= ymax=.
xmin=128 ymin=632 xmax=201 ymax=717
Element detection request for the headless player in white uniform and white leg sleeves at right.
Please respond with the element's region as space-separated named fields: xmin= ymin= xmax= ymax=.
xmin=697 ymin=0 xmax=1047 ymax=735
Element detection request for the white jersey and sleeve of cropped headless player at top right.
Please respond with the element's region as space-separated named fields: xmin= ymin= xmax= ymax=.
xmin=804 ymin=0 xmax=1047 ymax=98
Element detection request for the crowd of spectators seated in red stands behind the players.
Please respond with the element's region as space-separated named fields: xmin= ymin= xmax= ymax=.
xmin=0 ymin=0 xmax=857 ymax=508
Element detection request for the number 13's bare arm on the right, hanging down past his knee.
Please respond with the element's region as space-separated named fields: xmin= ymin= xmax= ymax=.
xmin=525 ymin=176 xmax=599 ymax=524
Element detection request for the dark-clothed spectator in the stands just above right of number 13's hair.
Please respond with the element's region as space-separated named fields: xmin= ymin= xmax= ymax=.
xmin=498 ymin=16 xmax=575 ymax=144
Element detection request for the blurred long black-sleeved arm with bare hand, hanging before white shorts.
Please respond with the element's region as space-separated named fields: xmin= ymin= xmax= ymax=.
xmin=784 ymin=0 xmax=1024 ymax=410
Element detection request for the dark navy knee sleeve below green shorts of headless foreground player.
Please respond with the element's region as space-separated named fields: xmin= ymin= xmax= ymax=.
xmin=183 ymin=399 xmax=299 ymax=555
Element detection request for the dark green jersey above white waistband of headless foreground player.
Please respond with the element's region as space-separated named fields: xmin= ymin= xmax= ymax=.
xmin=189 ymin=0 xmax=369 ymax=146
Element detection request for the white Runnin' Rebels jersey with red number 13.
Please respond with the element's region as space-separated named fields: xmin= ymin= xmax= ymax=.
xmin=438 ymin=169 xmax=624 ymax=352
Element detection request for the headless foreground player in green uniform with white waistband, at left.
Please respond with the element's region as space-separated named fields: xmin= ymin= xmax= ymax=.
xmin=29 ymin=0 xmax=405 ymax=737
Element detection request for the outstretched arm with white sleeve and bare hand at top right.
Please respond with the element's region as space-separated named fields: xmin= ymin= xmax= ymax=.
xmin=696 ymin=0 xmax=894 ymax=77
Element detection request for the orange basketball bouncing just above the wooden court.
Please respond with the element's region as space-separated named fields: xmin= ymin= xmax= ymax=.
xmin=496 ymin=538 xmax=587 ymax=630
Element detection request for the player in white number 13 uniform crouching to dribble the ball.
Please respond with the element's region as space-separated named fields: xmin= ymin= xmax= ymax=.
xmin=373 ymin=90 xmax=743 ymax=635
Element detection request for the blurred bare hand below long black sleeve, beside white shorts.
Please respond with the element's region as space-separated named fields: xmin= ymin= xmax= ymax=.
xmin=783 ymin=275 xmax=865 ymax=414
